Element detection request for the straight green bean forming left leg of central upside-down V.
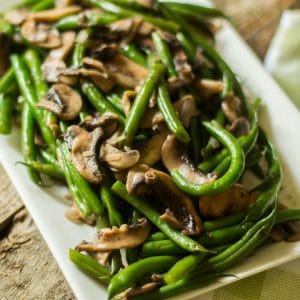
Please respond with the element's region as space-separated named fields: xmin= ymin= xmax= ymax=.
xmin=124 ymin=63 xmax=165 ymax=146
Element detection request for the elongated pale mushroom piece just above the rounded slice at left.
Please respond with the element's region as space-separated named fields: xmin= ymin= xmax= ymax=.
xmin=42 ymin=31 xmax=76 ymax=82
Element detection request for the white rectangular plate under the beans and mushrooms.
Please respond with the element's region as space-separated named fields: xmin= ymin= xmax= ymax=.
xmin=0 ymin=0 xmax=300 ymax=300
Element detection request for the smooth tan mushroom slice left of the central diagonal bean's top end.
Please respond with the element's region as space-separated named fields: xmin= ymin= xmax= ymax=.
xmin=106 ymin=54 xmax=148 ymax=89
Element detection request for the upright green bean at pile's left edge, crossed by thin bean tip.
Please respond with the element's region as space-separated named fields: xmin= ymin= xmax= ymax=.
xmin=21 ymin=102 xmax=42 ymax=185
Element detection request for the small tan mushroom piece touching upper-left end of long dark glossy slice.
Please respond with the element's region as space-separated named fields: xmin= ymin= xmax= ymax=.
xmin=126 ymin=165 xmax=151 ymax=195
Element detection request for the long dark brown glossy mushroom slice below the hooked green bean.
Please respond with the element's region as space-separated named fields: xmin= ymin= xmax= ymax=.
xmin=145 ymin=169 xmax=202 ymax=235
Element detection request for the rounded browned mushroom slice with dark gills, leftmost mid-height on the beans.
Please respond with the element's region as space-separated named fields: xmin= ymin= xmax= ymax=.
xmin=37 ymin=84 xmax=82 ymax=120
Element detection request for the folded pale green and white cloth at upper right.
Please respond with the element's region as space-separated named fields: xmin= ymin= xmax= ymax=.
xmin=265 ymin=9 xmax=300 ymax=108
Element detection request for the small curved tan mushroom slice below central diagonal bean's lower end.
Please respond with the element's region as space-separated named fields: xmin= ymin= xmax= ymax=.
xmin=100 ymin=143 xmax=140 ymax=170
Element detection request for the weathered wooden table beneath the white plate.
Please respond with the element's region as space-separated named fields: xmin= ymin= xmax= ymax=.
xmin=0 ymin=0 xmax=300 ymax=300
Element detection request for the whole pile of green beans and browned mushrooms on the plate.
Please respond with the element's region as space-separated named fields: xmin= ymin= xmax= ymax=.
xmin=0 ymin=0 xmax=300 ymax=299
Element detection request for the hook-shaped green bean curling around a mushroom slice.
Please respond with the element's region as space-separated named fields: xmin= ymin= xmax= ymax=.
xmin=171 ymin=122 xmax=245 ymax=196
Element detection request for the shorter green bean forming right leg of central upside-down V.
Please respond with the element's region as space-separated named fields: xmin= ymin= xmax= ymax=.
xmin=157 ymin=80 xmax=190 ymax=143
